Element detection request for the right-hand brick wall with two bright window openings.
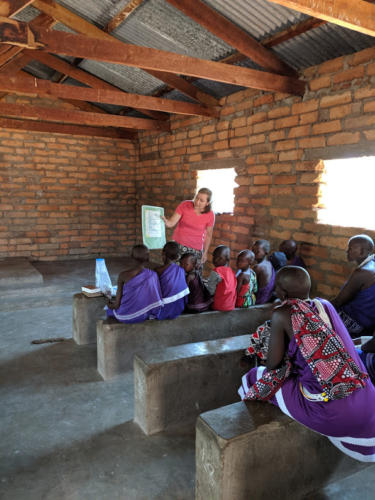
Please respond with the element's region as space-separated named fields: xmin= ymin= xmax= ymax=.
xmin=136 ymin=49 xmax=375 ymax=296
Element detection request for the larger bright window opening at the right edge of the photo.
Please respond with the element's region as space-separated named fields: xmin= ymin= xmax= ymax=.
xmin=318 ymin=156 xmax=375 ymax=229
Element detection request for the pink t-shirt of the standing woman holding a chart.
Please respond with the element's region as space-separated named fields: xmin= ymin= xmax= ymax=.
xmin=173 ymin=200 xmax=215 ymax=250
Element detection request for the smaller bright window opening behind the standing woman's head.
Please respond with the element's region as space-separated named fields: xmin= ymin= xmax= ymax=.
xmin=197 ymin=168 xmax=238 ymax=214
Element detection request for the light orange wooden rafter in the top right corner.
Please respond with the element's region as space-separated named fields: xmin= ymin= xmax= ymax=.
xmin=268 ymin=0 xmax=375 ymax=36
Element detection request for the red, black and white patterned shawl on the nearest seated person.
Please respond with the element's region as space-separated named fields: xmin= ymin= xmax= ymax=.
xmin=245 ymin=299 xmax=368 ymax=401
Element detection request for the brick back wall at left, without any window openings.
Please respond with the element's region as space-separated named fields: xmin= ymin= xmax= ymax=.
xmin=0 ymin=98 xmax=137 ymax=260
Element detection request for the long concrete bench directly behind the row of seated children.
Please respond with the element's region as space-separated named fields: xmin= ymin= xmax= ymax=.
xmin=97 ymin=304 xmax=272 ymax=379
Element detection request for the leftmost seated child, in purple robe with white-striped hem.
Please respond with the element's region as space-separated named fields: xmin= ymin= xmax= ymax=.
xmin=107 ymin=245 xmax=163 ymax=323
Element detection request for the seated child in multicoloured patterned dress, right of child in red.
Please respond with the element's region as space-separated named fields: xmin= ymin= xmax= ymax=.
xmin=236 ymin=250 xmax=258 ymax=308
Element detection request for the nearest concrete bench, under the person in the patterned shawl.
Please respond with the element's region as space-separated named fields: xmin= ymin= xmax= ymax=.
xmin=195 ymin=402 xmax=369 ymax=500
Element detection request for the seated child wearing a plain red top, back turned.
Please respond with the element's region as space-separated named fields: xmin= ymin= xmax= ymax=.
xmin=207 ymin=245 xmax=237 ymax=311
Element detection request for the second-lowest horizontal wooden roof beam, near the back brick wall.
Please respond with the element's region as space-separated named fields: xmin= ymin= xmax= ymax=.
xmin=0 ymin=102 xmax=169 ymax=131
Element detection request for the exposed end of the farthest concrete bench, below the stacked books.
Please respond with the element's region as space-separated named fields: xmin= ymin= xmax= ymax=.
xmin=73 ymin=293 xmax=106 ymax=345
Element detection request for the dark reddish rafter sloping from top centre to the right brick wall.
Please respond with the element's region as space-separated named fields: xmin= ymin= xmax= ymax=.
xmin=167 ymin=0 xmax=296 ymax=76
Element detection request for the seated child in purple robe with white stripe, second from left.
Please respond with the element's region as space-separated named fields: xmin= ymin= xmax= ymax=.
xmin=155 ymin=241 xmax=190 ymax=319
